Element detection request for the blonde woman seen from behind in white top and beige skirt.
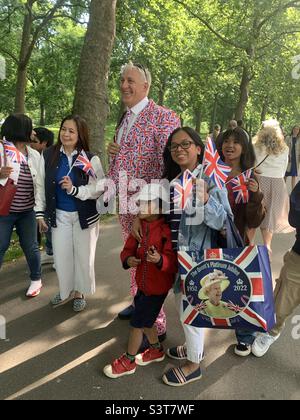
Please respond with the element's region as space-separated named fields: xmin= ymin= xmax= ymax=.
xmin=253 ymin=120 xmax=294 ymax=255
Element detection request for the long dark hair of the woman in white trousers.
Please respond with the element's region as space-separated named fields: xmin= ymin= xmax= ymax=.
xmin=51 ymin=115 xmax=90 ymax=166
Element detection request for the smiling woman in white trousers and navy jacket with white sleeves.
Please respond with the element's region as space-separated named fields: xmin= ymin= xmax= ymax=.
xmin=36 ymin=116 xmax=104 ymax=312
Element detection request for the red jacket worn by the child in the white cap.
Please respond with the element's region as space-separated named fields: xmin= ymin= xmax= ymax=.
xmin=121 ymin=218 xmax=178 ymax=296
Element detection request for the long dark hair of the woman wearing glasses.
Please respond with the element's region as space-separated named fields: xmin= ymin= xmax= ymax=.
xmin=163 ymin=127 xmax=205 ymax=181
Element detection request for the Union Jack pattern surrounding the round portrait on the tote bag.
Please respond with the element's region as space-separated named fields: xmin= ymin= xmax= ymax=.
xmin=178 ymin=246 xmax=276 ymax=332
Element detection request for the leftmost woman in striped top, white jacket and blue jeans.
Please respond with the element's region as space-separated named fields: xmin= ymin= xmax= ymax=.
xmin=0 ymin=114 xmax=42 ymax=297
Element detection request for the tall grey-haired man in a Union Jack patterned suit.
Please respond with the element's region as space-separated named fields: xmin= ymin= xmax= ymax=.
xmin=108 ymin=62 xmax=180 ymax=336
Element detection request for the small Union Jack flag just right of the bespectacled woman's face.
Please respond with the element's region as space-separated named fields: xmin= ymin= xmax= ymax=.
xmin=203 ymin=139 xmax=231 ymax=189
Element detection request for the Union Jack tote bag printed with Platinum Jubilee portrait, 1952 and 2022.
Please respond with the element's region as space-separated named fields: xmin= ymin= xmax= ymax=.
xmin=179 ymin=246 xmax=276 ymax=332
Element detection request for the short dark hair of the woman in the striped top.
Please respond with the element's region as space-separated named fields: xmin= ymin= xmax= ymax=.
xmin=1 ymin=114 xmax=32 ymax=143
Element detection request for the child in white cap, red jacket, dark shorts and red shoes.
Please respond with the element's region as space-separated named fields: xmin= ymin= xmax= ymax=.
xmin=104 ymin=184 xmax=178 ymax=379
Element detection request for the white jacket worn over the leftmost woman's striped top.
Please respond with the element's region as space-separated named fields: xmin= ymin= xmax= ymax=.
xmin=0 ymin=143 xmax=41 ymax=197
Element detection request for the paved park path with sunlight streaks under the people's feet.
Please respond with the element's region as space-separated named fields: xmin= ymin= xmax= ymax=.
xmin=0 ymin=218 xmax=300 ymax=400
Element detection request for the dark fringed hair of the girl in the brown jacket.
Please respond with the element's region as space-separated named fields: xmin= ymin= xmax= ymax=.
xmin=216 ymin=127 xmax=256 ymax=171
